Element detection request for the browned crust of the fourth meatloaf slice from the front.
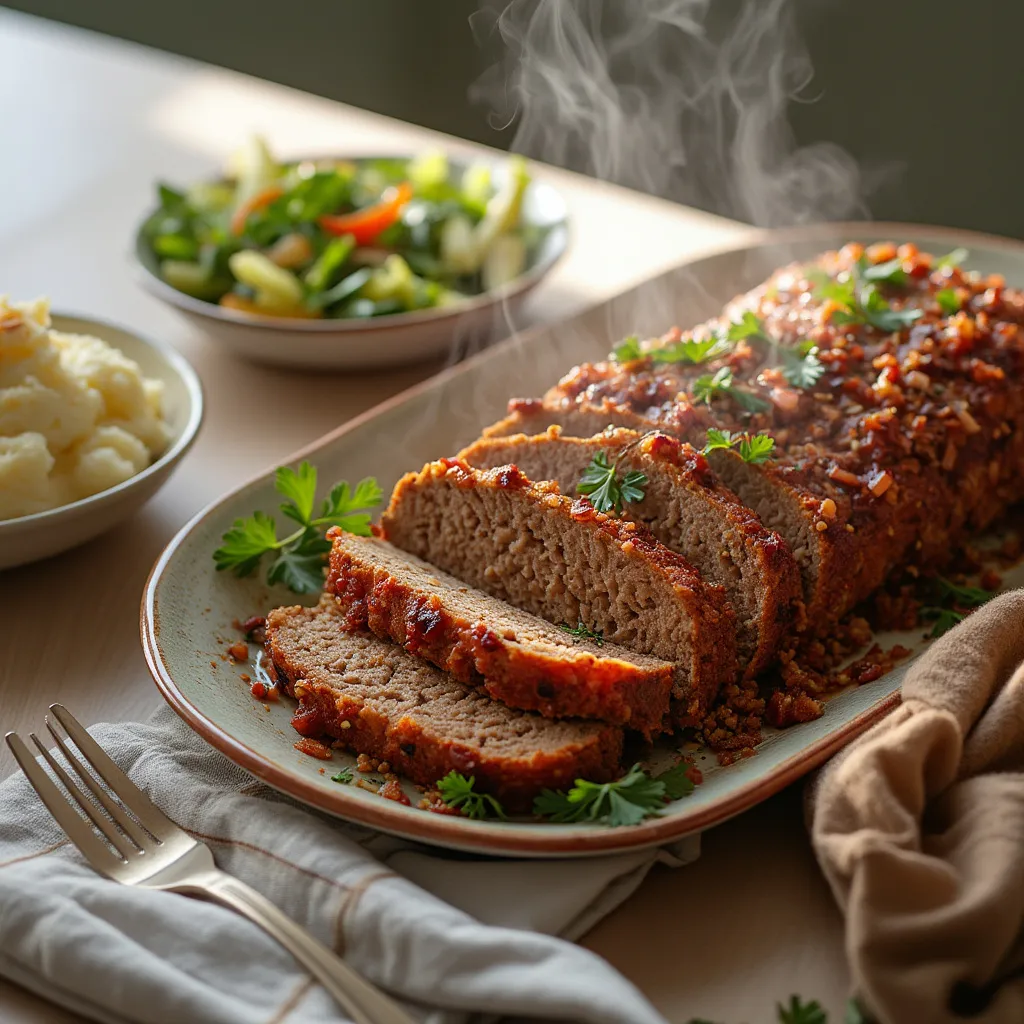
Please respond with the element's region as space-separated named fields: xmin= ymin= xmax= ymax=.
xmin=459 ymin=426 xmax=801 ymax=677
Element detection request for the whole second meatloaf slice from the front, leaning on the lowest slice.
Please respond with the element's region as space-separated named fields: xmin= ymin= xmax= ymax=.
xmin=327 ymin=529 xmax=673 ymax=735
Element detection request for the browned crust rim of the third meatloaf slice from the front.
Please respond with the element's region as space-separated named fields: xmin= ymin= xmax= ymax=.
xmin=380 ymin=459 xmax=736 ymax=727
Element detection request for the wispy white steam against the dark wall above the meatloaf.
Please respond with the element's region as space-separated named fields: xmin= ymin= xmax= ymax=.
xmin=473 ymin=0 xmax=866 ymax=226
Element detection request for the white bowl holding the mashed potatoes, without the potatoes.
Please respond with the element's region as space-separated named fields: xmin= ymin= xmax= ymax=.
xmin=0 ymin=313 xmax=203 ymax=569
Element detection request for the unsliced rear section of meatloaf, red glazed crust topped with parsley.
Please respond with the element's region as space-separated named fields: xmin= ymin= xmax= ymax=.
xmin=479 ymin=244 xmax=1024 ymax=631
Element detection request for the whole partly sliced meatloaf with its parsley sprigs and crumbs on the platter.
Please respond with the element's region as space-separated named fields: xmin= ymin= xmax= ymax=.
xmin=215 ymin=243 xmax=1024 ymax=825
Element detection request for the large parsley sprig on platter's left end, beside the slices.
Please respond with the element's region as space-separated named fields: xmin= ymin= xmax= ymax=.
xmin=213 ymin=462 xmax=382 ymax=594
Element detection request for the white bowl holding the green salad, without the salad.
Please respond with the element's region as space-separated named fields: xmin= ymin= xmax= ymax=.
xmin=135 ymin=157 xmax=568 ymax=370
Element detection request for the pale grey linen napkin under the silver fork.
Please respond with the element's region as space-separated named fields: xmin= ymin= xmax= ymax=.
xmin=0 ymin=708 xmax=699 ymax=1024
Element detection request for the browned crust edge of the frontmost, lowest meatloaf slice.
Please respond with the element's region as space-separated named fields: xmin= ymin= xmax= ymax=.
xmin=266 ymin=607 xmax=623 ymax=812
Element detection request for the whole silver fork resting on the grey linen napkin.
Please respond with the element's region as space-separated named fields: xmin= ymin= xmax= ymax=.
xmin=6 ymin=703 xmax=413 ymax=1024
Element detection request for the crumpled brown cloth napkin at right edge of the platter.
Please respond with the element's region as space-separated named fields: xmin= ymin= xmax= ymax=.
xmin=810 ymin=591 xmax=1024 ymax=1024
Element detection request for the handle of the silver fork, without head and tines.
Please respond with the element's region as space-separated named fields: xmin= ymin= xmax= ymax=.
xmin=178 ymin=870 xmax=415 ymax=1024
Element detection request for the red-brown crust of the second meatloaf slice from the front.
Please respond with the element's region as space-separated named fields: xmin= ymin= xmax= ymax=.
xmin=327 ymin=531 xmax=673 ymax=737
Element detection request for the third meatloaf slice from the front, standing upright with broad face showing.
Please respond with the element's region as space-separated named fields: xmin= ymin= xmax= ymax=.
xmin=381 ymin=459 xmax=736 ymax=724
